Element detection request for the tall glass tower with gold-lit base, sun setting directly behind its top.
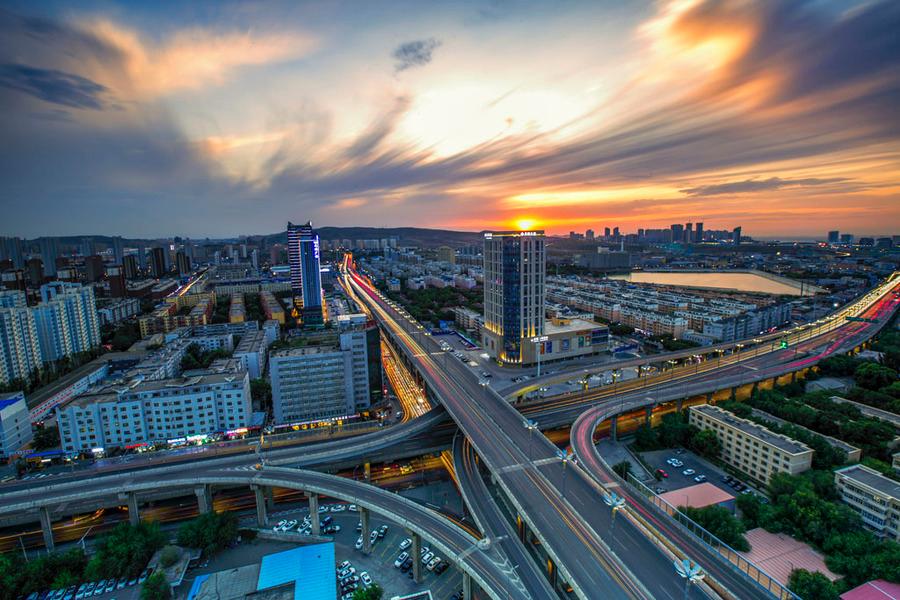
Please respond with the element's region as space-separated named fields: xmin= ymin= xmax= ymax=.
xmin=482 ymin=231 xmax=547 ymax=363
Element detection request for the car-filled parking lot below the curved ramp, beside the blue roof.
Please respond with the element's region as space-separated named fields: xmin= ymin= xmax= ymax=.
xmin=270 ymin=504 xmax=462 ymax=600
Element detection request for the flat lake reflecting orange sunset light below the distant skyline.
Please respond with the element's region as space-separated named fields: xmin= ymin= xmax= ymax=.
xmin=609 ymin=271 xmax=818 ymax=296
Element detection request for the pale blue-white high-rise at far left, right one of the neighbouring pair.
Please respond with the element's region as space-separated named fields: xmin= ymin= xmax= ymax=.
xmin=31 ymin=281 xmax=100 ymax=362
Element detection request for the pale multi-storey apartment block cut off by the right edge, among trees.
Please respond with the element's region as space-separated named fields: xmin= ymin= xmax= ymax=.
xmin=834 ymin=465 xmax=900 ymax=541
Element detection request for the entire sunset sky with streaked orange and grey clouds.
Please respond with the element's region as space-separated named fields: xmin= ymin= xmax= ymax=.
xmin=0 ymin=0 xmax=900 ymax=237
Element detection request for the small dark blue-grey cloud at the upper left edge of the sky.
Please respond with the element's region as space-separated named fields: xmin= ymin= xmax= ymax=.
xmin=0 ymin=64 xmax=108 ymax=110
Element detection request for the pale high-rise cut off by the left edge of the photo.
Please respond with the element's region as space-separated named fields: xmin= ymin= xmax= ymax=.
xmin=0 ymin=292 xmax=43 ymax=385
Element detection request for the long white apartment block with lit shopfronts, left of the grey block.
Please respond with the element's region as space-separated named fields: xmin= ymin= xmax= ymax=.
xmin=57 ymin=371 xmax=252 ymax=452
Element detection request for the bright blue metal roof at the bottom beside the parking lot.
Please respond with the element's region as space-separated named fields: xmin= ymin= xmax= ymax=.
xmin=256 ymin=542 xmax=337 ymax=600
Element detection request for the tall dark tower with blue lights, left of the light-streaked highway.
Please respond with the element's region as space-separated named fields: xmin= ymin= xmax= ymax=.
xmin=287 ymin=221 xmax=324 ymax=325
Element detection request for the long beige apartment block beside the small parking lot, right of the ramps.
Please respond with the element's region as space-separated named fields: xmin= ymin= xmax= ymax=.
xmin=689 ymin=404 xmax=813 ymax=483
